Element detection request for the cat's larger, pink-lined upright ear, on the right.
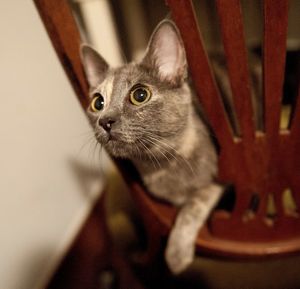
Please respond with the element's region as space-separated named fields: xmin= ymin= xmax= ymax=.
xmin=141 ymin=20 xmax=187 ymax=84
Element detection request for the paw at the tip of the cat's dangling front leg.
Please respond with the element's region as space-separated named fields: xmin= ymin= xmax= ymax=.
xmin=165 ymin=240 xmax=195 ymax=274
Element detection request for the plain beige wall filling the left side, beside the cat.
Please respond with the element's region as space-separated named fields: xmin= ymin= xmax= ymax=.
xmin=0 ymin=0 xmax=119 ymax=289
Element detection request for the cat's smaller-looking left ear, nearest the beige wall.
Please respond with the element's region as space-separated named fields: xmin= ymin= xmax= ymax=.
xmin=80 ymin=44 xmax=109 ymax=88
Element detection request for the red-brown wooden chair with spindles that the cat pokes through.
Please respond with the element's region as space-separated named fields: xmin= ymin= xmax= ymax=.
xmin=35 ymin=0 xmax=300 ymax=274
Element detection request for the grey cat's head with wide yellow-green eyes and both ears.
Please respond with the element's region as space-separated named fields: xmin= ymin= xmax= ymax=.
xmin=81 ymin=21 xmax=191 ymax=158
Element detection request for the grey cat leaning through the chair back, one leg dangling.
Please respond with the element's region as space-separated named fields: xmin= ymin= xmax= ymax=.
xmin=81 ymin=21 xmax=222 ymax=273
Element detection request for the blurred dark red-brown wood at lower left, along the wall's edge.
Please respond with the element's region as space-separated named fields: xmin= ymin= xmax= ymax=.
xmin=46 ymin=197 xmax=112 ymax=289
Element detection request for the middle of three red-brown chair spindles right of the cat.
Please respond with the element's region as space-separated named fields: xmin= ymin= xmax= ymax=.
xmin=216 ymin=0 xmax=255 ymax=141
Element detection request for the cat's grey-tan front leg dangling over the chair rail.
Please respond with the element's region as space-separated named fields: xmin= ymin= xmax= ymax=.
xmin=165 ymin=184 xmax=223 ymax=274
